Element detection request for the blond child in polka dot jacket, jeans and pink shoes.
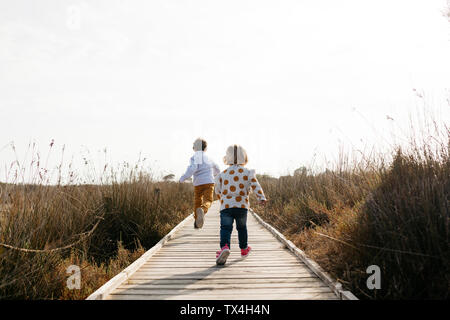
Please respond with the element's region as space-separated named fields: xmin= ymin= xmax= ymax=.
xmin=214 ymin=145 xmax=266 ymax=265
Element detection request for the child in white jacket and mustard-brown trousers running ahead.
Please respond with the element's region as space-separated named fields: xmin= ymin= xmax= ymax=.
xmin=179 ymin=138 xmax=220 ymax=229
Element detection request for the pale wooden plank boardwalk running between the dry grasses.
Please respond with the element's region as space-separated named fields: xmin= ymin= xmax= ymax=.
xmin=88 ymin=201 xmax=355 ymax=300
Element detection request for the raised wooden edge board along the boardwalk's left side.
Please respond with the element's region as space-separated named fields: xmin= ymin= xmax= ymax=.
xmin=86 ymin=213 xmax=194 ymax=300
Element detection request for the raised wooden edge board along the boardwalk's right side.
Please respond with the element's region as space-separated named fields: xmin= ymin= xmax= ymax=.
xmin=249 ymin=209 xmax=358 ymax=300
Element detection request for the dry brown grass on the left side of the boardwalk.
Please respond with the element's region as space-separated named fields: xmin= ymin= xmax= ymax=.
xmin=0 ymin=154 xmax=192 ymax=299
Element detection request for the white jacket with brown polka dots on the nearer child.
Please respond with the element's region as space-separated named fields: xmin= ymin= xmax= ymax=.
xmin=214 ymin=165 xmax=266 ymax=210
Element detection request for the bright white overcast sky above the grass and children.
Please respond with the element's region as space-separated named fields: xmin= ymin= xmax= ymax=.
xmin=0 ymin=0 xmax=450 ymax=180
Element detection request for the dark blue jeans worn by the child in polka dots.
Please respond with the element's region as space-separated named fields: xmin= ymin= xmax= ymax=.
xmin=220 ymin=208 xmax=248 ymax=249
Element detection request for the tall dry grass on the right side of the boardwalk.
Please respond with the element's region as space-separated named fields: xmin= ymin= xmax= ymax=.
xmin=257 ymin=125 xmax=450 ymax=299
